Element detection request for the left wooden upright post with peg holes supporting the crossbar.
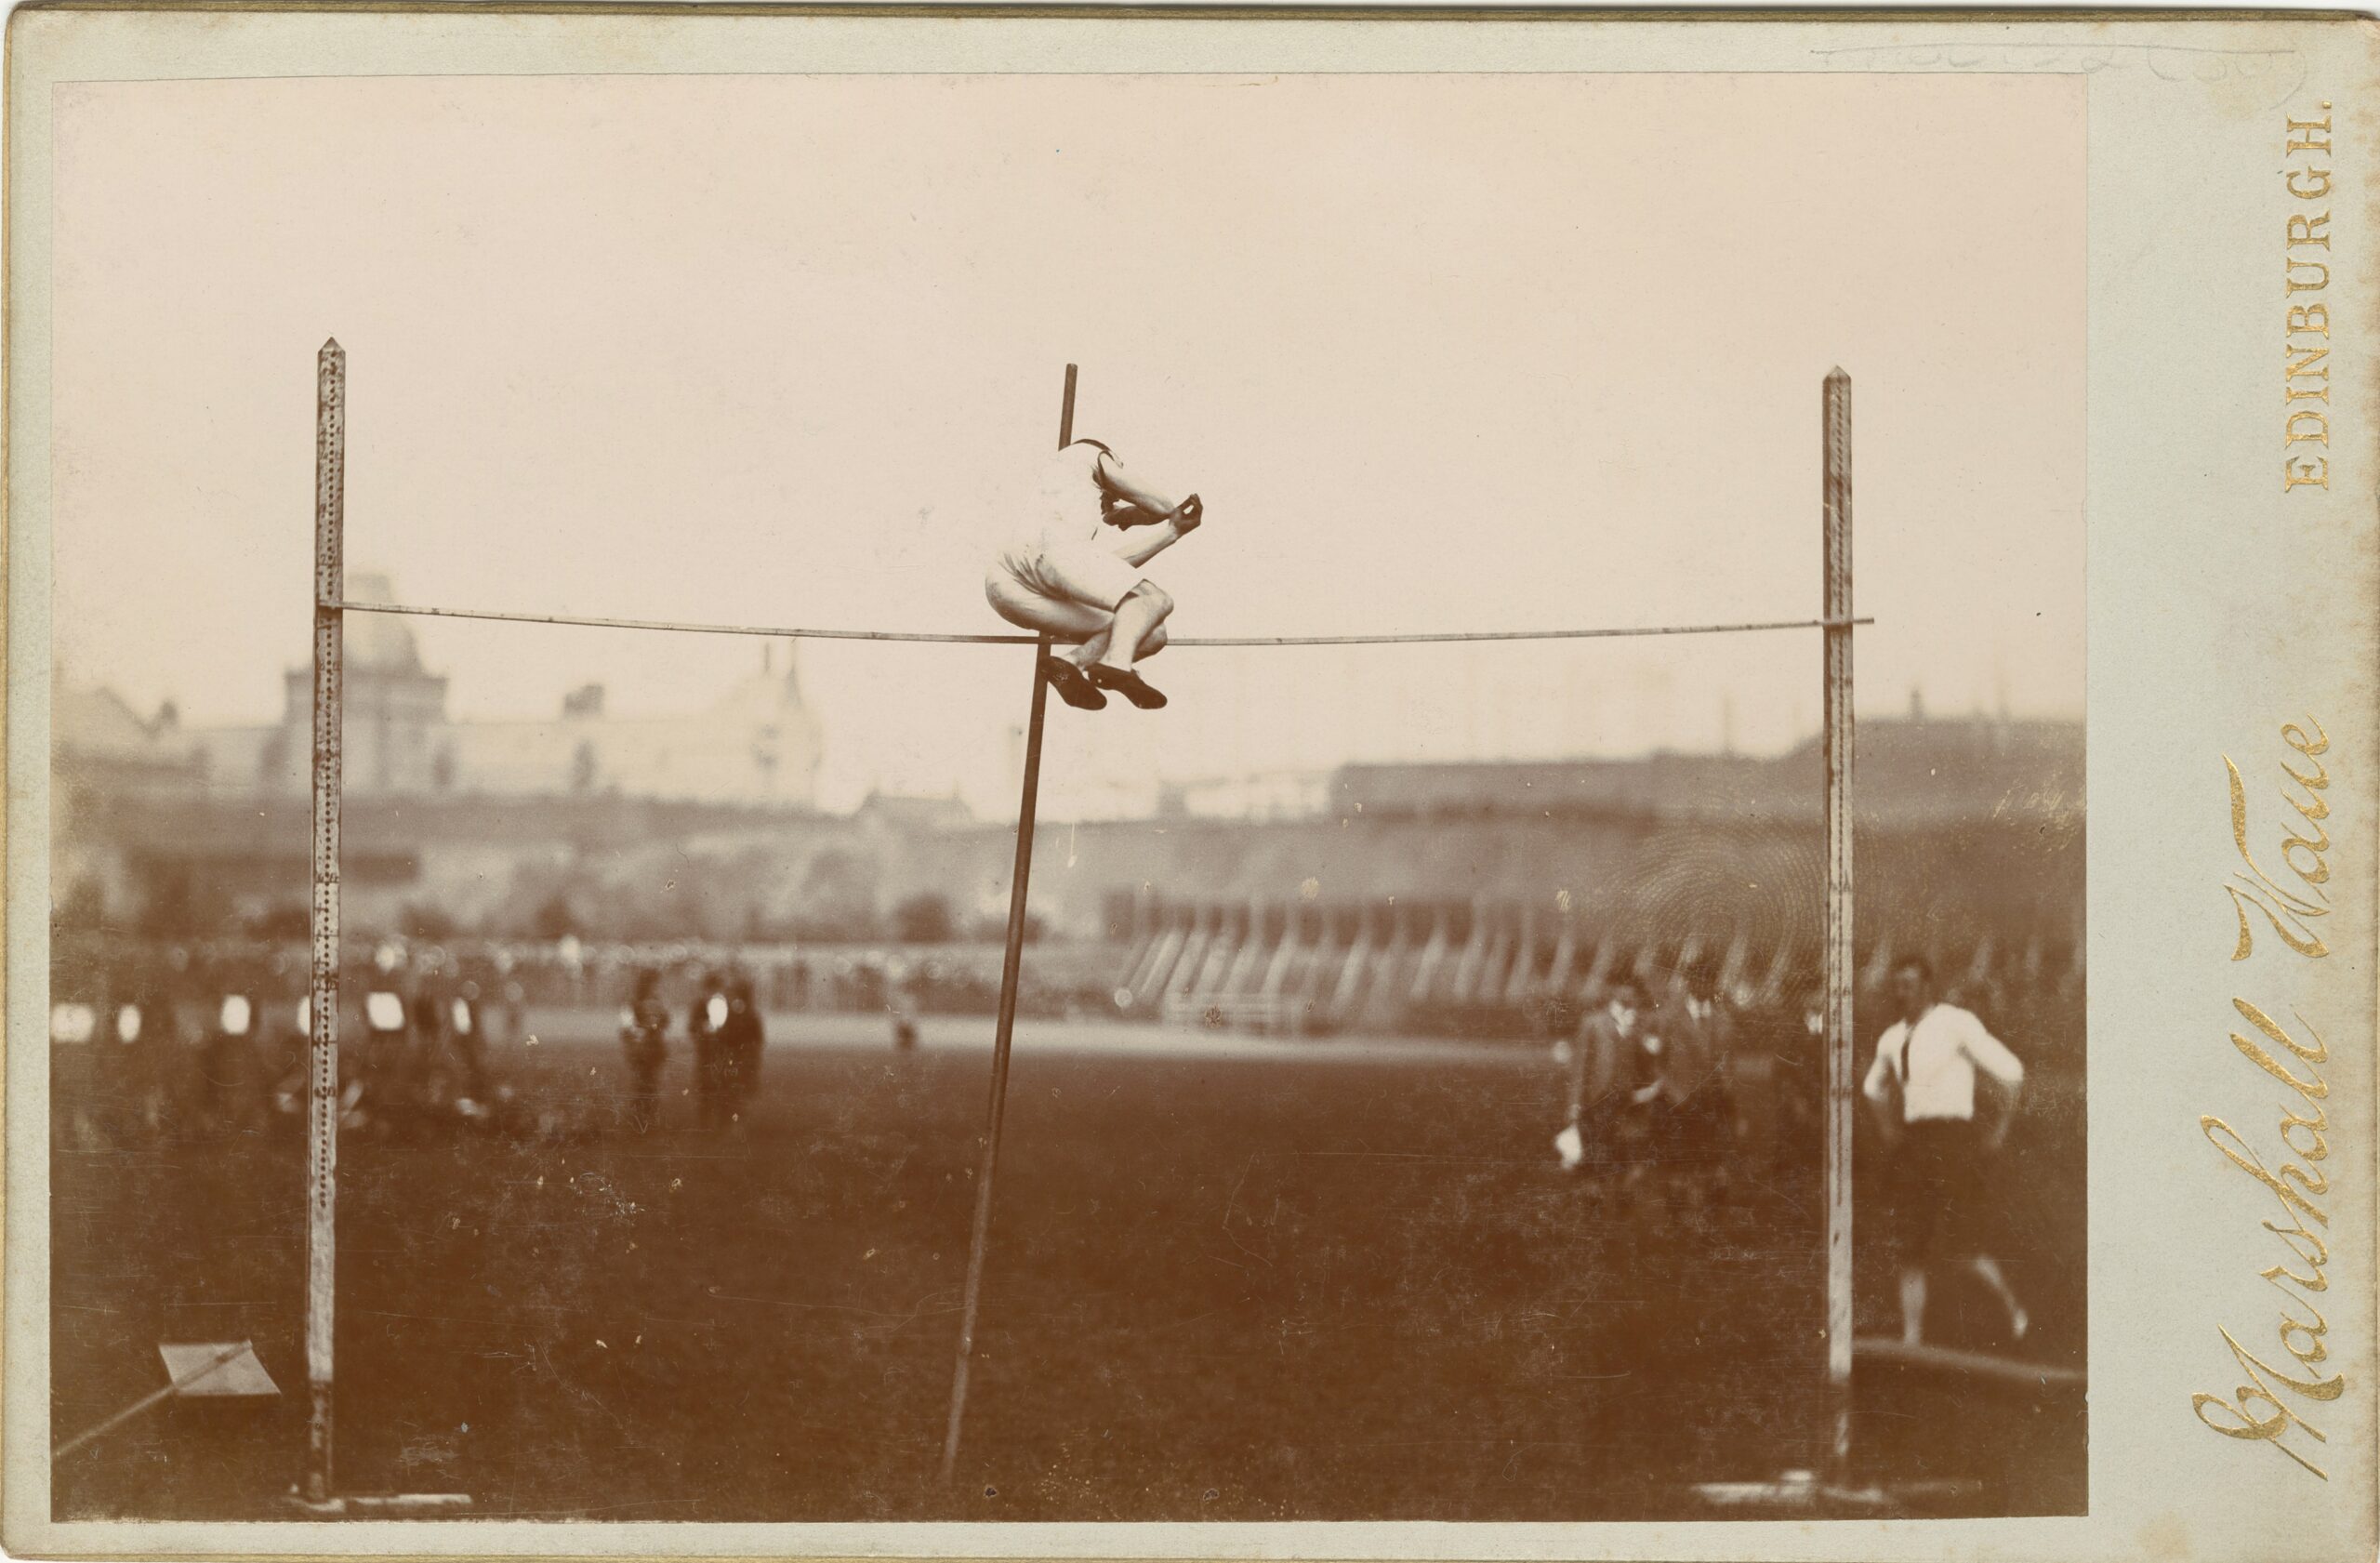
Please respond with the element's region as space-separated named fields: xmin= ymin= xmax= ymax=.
xmin=305 ymin=340 xmax=348 ymax=1503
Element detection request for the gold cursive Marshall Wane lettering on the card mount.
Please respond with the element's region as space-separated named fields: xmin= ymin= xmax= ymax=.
xmin=2189 ymin=716 xmax=2347 ymax=1482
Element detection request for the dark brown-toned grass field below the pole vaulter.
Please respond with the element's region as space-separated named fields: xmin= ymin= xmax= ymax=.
xmin=52 ymin=1011 xmax=2085 ymax=1520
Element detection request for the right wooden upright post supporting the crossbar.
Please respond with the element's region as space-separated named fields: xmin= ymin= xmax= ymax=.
xmin=1820 ymin=369 xmax=1854 ymax=1468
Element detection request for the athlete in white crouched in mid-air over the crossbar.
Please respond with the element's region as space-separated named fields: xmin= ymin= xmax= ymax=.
xmin=983 ymin=440 xmax=1204 ymax=711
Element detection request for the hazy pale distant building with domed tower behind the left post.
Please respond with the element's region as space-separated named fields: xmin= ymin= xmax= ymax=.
xmin=188 ymin=576 xmax=821 ymax=809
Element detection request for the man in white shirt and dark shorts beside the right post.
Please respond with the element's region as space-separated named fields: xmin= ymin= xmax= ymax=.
xmin=1858 ymin=957 xmax=2032 ymax=1346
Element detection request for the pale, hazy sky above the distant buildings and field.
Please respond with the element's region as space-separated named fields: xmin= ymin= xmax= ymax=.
xmin=52 ymin=73 xmax=2085 ymax=816
